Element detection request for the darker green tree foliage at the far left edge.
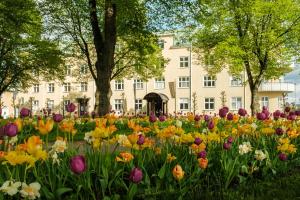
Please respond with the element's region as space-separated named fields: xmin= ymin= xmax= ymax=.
xmin=0 ymin=0 xmax=63 ymax=95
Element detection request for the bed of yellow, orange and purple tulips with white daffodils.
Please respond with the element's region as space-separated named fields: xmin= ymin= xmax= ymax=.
xmin=0 ymin=107 xmax=300 ymax=200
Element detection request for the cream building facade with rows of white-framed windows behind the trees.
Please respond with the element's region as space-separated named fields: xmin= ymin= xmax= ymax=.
xmin=1 ymin=34 xmax=295 ymax=117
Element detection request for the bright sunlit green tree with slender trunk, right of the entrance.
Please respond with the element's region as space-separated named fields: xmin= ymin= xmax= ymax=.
xmin=195 ymin=0 xmax=300 ymax=114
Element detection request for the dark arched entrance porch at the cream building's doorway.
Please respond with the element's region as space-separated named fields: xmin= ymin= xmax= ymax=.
xmin=144 ymin=92 xmax=169 ymax=116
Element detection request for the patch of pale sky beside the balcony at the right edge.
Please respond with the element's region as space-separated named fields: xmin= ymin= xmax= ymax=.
xmin=284 ymin=63 xmax=300 ymax=104
